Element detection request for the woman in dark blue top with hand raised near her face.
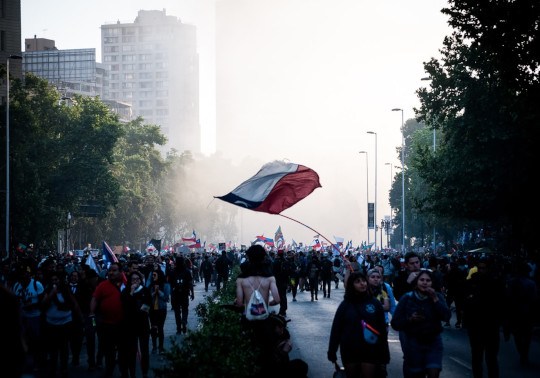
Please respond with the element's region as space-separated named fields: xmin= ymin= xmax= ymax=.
xmin=391 ymin=269 xmax=451 ymax=378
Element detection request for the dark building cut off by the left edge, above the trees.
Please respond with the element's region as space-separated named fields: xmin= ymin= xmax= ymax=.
xmin=0 ymin=0 xmax=22 ymax=103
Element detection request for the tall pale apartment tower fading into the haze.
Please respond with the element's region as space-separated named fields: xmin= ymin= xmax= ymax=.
xmin=101 ymin=10 xmax=201 ymax=154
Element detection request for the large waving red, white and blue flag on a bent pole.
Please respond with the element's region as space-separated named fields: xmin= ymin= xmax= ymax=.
xmin=215 ymin=161 xmax=321 ymax=214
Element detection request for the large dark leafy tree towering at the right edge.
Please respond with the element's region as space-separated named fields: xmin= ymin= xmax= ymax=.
xmin=414 ymin=0 xmax=540 ymax=252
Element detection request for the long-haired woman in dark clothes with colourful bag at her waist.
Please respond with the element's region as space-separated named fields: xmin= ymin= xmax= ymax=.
xmin=327 ymin=272 xmax=390 ymax=378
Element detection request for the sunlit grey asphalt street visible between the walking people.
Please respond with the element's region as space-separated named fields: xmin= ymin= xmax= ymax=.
xmin=25 ymin=283 xmax=540 ymax=378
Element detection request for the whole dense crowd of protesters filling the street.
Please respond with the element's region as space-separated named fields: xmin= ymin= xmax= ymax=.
xmin=1 ymin=246 xmax=539 ymax=378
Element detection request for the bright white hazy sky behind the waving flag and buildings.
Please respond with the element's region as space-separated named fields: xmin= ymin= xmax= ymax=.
xmin=21 ymin=0 xmax=450 ymax=248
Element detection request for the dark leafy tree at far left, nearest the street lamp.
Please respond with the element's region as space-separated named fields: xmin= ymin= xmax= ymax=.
xmin=2 ymin=74 xmax=122 ymax=249
